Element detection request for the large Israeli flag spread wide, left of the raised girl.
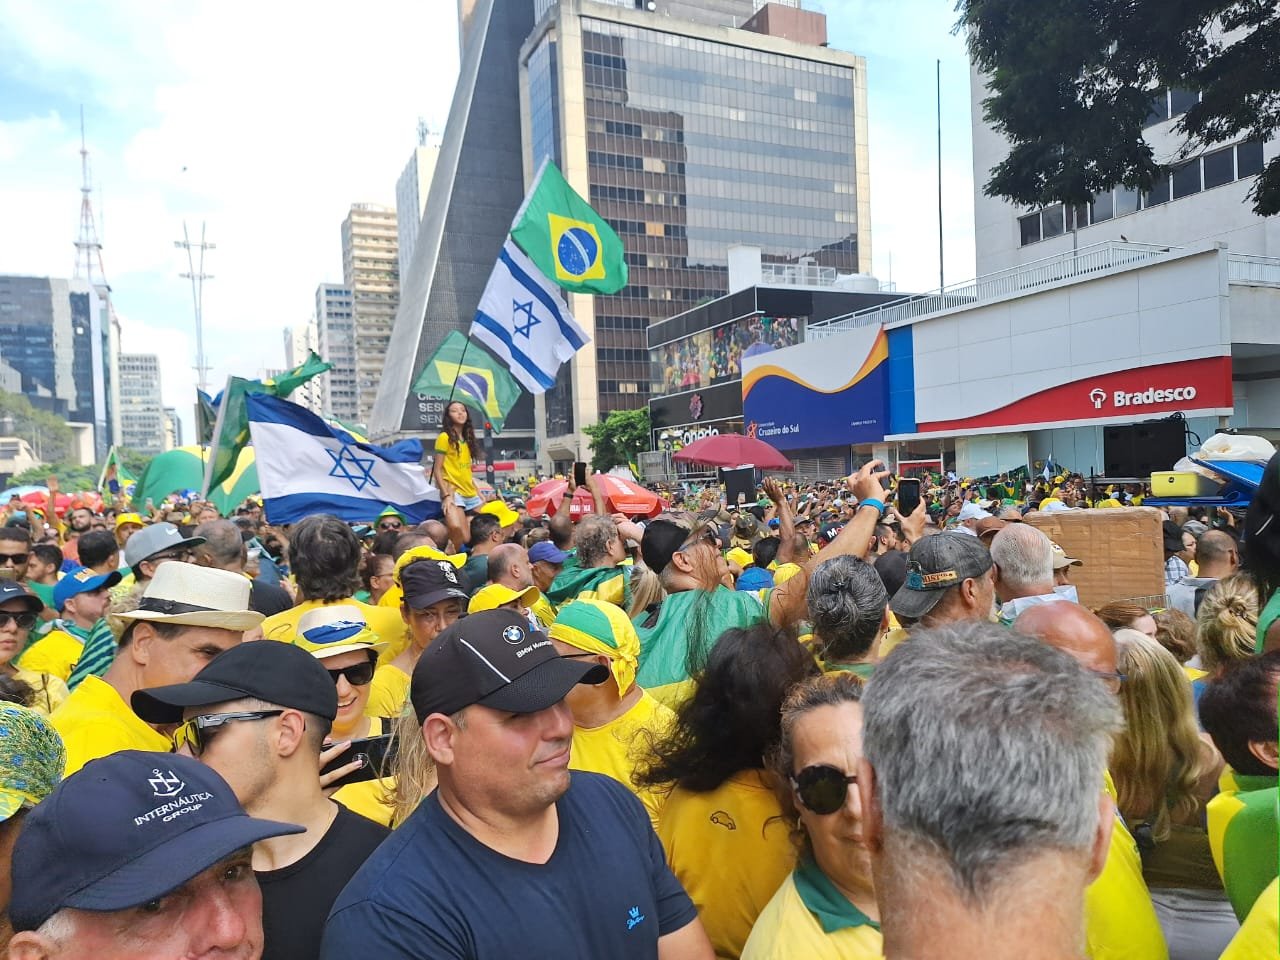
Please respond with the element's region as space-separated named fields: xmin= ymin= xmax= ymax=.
xmin=244 ymin=393 xmax=442 ymax=524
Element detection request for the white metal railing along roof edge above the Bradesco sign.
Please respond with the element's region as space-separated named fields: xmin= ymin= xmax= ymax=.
xmin=806 ymin=241 xmax=1178 ymax=339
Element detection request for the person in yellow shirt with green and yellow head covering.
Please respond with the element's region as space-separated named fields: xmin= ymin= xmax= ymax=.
xmin=547 ymin=600 xmax=676 ymax=828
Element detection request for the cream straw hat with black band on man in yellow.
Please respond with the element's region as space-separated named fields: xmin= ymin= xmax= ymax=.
xmin=115 ymin=563 xmax=262 ymax=630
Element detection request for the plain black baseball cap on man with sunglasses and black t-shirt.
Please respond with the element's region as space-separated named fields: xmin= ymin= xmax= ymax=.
xmin=129 ymin=640 xmax=338 ymax=723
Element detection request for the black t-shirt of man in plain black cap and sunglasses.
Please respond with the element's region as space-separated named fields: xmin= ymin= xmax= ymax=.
xmin=257 ymin=804 xmax=390 ymax=960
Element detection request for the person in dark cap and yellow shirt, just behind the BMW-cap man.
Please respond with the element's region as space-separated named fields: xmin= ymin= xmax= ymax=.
xmin=365 ymin=557 xmax=467 ymax=717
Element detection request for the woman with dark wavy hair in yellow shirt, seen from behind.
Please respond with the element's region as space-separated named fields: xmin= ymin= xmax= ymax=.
xmin=637 ymin=623 xmax=818 ymax=959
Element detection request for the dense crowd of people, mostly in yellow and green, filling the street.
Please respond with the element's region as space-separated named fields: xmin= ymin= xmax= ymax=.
xmin=0 ymin=404 xmax=1280 ymax=960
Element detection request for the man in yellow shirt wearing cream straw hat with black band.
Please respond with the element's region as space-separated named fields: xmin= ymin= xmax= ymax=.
xmin=51 ymin=563 xmax=262 ymax=776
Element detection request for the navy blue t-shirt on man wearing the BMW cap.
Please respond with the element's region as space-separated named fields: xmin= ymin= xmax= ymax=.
xmin=320 ymin=771 xmax=698 ymax=960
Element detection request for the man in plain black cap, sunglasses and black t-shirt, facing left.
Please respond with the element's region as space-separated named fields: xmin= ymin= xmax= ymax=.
xmin=132 ymin=640 xmax=388 ymax=960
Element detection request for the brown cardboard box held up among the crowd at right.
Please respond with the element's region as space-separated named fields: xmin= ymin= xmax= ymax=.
xmin=1027 ymin=507 xmax=1165 ymax=608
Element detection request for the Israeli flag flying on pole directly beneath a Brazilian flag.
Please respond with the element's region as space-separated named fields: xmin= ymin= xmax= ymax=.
xmin=471 ymin=237 xmax=590 ymax=393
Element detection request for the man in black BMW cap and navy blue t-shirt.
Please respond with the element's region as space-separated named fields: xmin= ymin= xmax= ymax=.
xmin=320 ymin=609 xmax=713 ymax=960
